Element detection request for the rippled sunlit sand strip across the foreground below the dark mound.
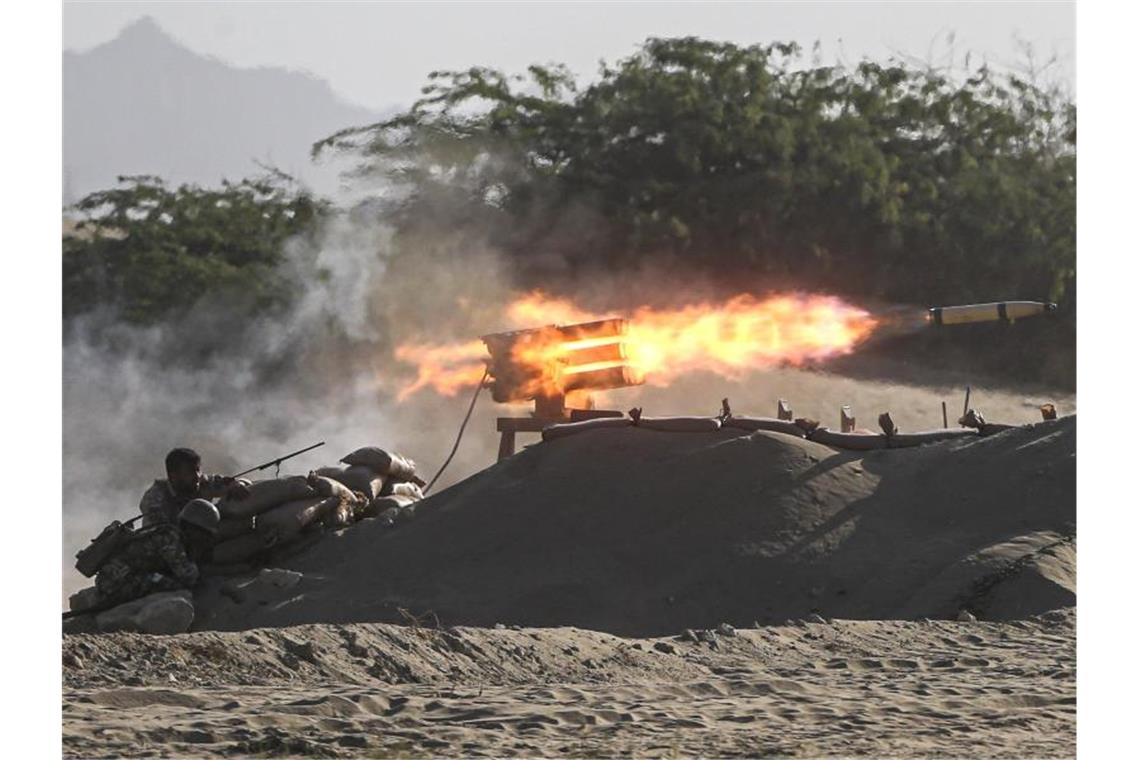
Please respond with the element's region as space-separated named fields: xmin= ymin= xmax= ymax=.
xmin=63 ymin=608 xmax=1076 ymax=758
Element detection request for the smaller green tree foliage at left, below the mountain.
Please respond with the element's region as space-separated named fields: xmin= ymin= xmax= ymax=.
xmin=63 ymin=173 xmax=326 ymax=325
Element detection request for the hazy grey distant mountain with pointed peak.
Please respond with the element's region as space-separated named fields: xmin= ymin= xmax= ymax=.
xmin=64 ymin=17 xmax=382 ymax=203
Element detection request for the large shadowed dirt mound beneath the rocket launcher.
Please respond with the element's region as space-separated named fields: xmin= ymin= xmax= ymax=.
xmin=195 ymin=416 xmax=1076 ymax=635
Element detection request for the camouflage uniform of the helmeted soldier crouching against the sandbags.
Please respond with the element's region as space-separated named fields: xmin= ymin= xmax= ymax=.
xmin=95 ymin=524 xmax=198 ymax=604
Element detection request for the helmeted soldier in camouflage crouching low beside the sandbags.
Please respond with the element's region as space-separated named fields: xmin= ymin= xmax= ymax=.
xmin=95 ymin=499 xmax=221 ymax=604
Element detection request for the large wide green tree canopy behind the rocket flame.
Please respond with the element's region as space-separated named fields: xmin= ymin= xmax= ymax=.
xmin=314 ymin=38 xmax=1076 ymax=302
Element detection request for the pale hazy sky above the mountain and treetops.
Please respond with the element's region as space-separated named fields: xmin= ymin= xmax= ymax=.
xmin=64 ymin=1 xmax=1076 ymax=108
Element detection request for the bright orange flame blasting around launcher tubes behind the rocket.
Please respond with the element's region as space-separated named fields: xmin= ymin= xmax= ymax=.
xmin=396 ymin=292 xmax=878 ymax=400
